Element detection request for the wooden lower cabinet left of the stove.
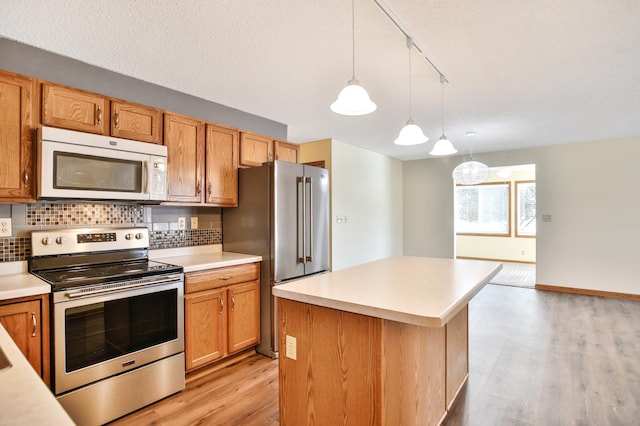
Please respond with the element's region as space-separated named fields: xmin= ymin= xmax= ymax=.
xmin=0 ymin=294 xmax=50 ymax=386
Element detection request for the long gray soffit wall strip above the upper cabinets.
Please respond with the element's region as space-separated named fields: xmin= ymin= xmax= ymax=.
xmin=0 ymin=38 xmax=287 ymax=140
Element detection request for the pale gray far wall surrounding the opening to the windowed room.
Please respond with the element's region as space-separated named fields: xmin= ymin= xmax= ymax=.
xmin=403 ymin=138 xmax=640 ymax=294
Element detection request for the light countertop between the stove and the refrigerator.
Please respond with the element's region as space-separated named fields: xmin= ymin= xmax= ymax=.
xmin=149 ymin=244 xmax=262 ymax=272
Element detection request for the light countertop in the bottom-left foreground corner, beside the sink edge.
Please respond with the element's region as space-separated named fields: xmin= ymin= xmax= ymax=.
xmin=0 ymin=325 xmax=74 ymax=425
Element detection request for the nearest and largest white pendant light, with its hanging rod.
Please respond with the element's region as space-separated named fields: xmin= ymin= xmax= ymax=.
xmin=330 ymin=0 xmax=377 ymax=115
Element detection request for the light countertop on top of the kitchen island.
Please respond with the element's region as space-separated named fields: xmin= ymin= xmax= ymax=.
xmin=273 ymin=256 xmax=502 ymax=327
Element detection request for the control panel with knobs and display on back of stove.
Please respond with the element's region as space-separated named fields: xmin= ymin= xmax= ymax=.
xmin=31 ymin=228 xmax=149 ymax=256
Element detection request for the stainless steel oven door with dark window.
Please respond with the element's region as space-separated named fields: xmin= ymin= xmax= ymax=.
xmin=53 ymin=275 xmax=184 ymax=395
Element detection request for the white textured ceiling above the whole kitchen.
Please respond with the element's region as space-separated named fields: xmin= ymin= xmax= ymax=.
xmin=0 ymin=0 xmax=640 ymax=160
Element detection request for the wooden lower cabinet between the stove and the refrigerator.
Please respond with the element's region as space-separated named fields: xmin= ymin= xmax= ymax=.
xmin=184 ymin=263 xmax=260 ymax=371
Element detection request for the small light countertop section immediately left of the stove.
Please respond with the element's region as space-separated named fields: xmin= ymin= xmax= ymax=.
xmin=0 ymin=261 xmax=51 ymax=301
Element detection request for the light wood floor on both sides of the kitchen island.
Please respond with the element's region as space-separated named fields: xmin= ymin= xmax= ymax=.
xmin=115 ymin=285 xmax=640 ymax=426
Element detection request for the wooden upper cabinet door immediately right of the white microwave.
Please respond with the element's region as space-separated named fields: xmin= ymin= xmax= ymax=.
xmin=164 ymin=114 xmax=204 ymax=203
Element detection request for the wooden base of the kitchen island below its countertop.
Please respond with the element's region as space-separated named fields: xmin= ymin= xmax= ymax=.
xmin=278 ymin=299 xmax=468 ymax=426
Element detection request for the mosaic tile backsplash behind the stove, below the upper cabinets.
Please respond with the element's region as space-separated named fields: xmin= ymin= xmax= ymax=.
xmin=0 ymin=203 xmax=222 ymax=262
